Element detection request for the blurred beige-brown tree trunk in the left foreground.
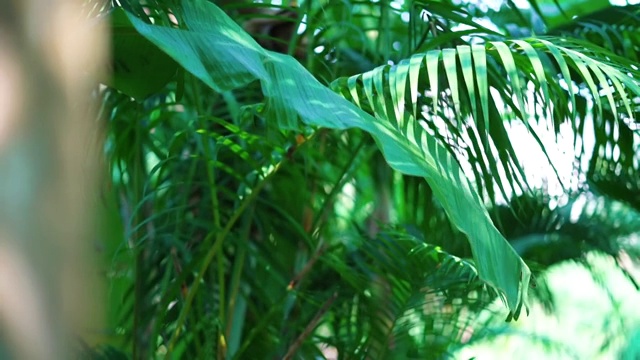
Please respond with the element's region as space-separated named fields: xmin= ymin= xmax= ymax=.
xmin=0 ymin=0 xmax=106 ymax=359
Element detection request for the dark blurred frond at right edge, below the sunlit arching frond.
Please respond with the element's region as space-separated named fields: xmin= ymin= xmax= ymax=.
xmin=495 ymin=193 xmax=640 ymax=267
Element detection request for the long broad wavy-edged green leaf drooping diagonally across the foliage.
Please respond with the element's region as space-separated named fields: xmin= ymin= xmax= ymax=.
xmin=124 ymin=1 xmax=530 ymax=319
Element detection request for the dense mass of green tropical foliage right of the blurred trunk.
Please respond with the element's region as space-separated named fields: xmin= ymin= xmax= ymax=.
xmin=95 ymin=0 xmax=640 ymax=358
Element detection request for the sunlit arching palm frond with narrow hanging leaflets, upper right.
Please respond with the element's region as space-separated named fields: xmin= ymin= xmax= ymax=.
xmin=335 ymin=37 xmax=640 ymax=204
